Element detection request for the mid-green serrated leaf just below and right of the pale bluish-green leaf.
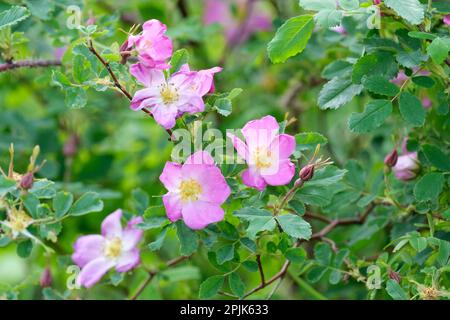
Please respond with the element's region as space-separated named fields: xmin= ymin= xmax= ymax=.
xmin=349 ymin=100 xmax=392 ymax=133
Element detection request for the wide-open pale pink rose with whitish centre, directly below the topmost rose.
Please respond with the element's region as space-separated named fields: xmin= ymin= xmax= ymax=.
xmin=130 ymin=63 xmax=222 ymax=129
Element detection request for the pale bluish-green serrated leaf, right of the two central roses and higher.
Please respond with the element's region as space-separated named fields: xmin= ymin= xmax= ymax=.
xmin=318 ymin=78 xmax=362 ymax=109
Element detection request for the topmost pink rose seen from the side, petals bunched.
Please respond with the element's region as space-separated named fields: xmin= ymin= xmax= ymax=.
xmin=127 ymin=19 xmax=172 ymax=70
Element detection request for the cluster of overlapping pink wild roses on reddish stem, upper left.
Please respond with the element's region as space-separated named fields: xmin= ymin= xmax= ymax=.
xmin=125 ymin=19 xmax=222 ymax=129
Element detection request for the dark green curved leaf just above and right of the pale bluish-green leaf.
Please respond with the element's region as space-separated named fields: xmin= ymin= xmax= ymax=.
xmin=352 ymin=52 xmax=398 ymax=84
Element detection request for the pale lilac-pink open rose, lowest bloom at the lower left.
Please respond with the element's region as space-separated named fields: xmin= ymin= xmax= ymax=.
xmin=72 ymin=209 xmax=143 ymax=288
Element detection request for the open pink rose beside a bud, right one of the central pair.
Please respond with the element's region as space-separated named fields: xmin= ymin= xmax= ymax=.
xmin=228 ymin=116 xmax=295 ymax=191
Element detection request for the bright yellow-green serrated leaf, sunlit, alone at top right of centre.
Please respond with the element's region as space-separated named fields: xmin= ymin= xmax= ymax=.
xmin=267 ymin=15 xmax=314 ymax=63
